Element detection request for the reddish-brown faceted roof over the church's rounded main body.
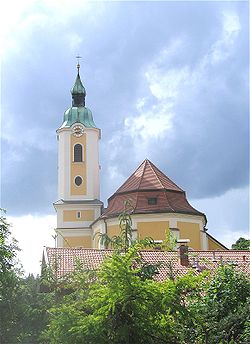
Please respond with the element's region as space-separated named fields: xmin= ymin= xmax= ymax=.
xmin=101 ymin=159 xmax=205 ymax=218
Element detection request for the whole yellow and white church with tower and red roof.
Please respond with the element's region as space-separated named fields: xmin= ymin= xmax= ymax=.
xmin=54 ymin=63 xmax=227 ymax=251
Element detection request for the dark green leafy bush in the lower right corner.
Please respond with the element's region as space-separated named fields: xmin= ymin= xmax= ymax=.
xmin=203 ymin=265 xmax=250 ymax=343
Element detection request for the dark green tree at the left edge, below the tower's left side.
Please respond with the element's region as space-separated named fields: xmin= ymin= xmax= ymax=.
xmin=0 ymin=211 xmax=55 ymax=344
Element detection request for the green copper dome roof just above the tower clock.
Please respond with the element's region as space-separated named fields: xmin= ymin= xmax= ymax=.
xmin=59 ymin=106 xmax=97 ymax=129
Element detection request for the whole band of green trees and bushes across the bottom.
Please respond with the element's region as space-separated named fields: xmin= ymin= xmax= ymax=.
xmin=0 ymin=209 xmax=250 ymax=344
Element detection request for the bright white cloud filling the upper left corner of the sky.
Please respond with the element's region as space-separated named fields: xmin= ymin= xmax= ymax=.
xmin=0 ymin=0 xmax=93 ymax=59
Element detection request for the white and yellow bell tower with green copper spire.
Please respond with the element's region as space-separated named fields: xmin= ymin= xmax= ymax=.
xmin=54 ymin=63 xmax=103 ymax=248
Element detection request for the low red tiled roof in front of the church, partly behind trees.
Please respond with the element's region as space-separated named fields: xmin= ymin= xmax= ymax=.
xmin=44 ymin=247 xmax=250 ymax=281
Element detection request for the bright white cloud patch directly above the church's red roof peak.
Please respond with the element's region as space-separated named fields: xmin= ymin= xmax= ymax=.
xmin=121 ymin=39 xmax=190 ymax=145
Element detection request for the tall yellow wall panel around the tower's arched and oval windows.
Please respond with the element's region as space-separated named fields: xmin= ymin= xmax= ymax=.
xmin=70 ymin=134 xmax=87 ymax=195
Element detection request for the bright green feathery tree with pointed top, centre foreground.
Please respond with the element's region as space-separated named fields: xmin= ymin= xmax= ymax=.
xmin=44 ymin=204 xmax=198 ymax=344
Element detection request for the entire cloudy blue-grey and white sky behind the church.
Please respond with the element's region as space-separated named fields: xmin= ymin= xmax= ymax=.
xmin=0 ymin=0 xmax=249 ymax=273
